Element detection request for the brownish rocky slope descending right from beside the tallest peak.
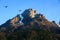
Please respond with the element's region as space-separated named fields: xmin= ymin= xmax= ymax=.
xmin=28 ymin=14 xmax=58 ymax=31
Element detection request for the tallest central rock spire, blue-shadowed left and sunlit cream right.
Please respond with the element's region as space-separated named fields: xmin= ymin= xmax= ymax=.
xmin=21 ymin=8 xmax=36 ymax=25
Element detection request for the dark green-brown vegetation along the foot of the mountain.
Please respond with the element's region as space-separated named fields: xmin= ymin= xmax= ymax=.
xmin=0 ymin=28 xmax=60 ymax=40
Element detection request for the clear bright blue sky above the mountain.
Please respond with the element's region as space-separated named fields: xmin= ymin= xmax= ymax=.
xmin=0 ymin=0 xmax=60 ymax=25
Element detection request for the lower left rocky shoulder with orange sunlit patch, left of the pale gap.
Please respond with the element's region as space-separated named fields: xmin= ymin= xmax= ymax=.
xmin=0 ymin=14 xmax=21 ymax=31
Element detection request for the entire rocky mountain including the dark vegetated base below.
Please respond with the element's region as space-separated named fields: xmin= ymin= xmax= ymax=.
xmin=0 ymin=8 xmax=60 ymax=40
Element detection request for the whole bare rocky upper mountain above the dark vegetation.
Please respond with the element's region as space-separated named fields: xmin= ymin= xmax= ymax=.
xmin=0 ymin=8 xmax=60 ymax=33
